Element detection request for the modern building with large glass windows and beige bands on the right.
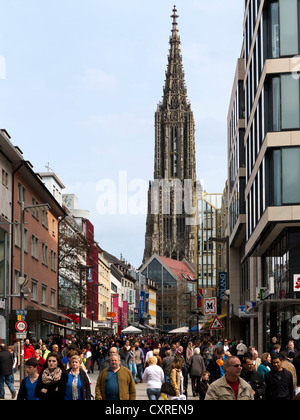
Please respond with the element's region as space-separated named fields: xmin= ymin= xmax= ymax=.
xmin=228 ymin=0 xmax=300 ymax=351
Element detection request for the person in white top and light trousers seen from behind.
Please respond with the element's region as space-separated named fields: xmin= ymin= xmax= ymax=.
xmin=143 ymin=356 xmax=165 ymax=400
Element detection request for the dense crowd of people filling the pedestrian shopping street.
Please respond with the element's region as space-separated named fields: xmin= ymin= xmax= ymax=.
xmin=0 ymin=334 xmax=300 ymax=401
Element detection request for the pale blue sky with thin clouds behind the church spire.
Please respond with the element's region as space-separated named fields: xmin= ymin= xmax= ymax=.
xmin=0 ymin=0 xmax=244 ymax=268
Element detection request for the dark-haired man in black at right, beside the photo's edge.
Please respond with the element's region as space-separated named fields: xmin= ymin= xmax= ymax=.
xmin=265 ymin=354 xmax=294 ymax=401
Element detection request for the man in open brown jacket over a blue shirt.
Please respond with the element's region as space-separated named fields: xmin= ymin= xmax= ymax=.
xmin=95 ymin=354 xmax=136 ymax=401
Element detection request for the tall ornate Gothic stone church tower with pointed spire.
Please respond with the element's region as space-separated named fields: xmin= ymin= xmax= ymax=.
xmin=144 ymin=6 xmax=196 ymax=262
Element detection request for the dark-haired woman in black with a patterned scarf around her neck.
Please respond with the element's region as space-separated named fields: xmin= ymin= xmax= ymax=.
xmin=35 ymin=353 xmax=68 ymax=401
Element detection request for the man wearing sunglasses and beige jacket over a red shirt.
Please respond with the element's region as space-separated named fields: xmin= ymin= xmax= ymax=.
xmin=205 ymin=356 xmax=254 ymax=401
